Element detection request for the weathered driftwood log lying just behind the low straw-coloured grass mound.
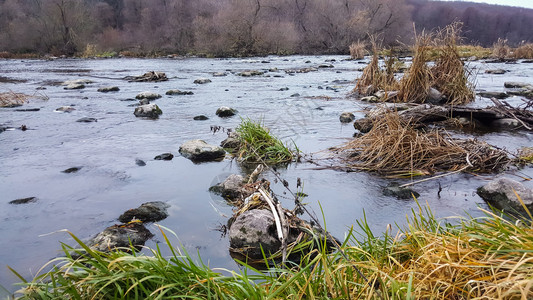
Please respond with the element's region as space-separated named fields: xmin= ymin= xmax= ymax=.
xmin=354 ymin=98 xmax=533 ymax=133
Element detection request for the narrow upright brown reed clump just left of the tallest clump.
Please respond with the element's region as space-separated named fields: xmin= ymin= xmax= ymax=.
xmin=398 ymin=32 xmax=433 ymax=103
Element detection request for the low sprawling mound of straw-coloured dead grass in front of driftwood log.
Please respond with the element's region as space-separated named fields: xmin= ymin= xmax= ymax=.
xmin=340 ymin=112 xmax=509 ymax=176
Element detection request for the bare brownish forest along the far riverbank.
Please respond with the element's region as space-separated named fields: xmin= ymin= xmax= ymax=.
xmin=0 ymin=0 xmax=533 ymax=56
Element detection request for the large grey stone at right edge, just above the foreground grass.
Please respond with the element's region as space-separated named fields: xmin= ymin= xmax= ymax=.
xmin=477 ymin=178 xmax=533 ymax=216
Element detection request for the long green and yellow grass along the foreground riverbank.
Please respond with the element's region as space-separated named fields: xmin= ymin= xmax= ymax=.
xmin=10 ymin=205 xmax=533 ymax=299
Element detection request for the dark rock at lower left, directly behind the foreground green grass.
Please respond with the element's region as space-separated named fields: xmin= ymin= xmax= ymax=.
xmin=86 ymin=222 xmax=154 ymax=252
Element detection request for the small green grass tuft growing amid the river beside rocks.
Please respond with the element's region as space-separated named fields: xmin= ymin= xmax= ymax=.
xmin=235 ymin=119 xmax=300 ymax=164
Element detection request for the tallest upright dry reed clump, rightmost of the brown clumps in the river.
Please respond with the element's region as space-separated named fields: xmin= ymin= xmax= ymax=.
xmin=431 ymin=23 xmax=475 ymax=105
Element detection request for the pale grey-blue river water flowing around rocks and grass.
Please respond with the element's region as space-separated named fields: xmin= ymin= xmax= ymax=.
xmin=0 ymin=56 xmax=533 ymax=291
